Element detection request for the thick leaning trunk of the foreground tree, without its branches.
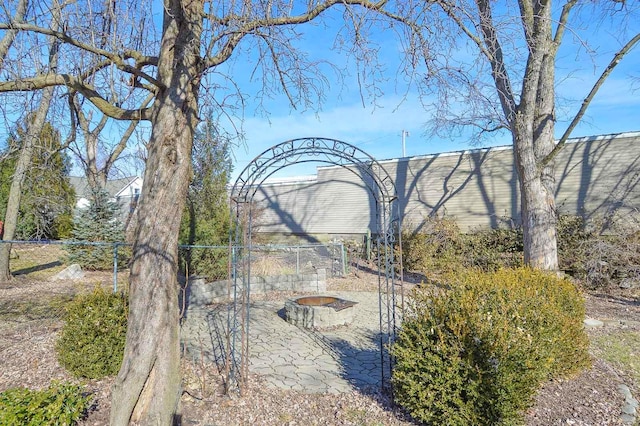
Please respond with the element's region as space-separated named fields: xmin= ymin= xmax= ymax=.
xmin=111 ymin=0 xmax=202 ymax=426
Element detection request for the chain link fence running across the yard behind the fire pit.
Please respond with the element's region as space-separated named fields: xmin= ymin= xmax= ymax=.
xmin=0 ymin=240 xmax=348 ymax=291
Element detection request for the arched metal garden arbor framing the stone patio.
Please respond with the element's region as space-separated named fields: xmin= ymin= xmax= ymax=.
xmin=225 ymin=137 xmax=402 ymax=392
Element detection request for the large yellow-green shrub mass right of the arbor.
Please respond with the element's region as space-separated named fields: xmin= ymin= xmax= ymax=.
xmin=391 ymin=268 xmax=589 ymax=425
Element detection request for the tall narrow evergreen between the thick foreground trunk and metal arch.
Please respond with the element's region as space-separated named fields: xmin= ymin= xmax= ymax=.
xmin=179 ymin=119 xmax=232 ymax=278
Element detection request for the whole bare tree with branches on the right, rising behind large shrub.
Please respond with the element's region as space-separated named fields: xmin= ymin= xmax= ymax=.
xmin=387 ymin=0 xmax=640 ymax=270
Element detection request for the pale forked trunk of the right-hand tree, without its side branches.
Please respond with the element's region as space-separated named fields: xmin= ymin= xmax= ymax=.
xmin=512 ymin=3 xmax=558 ymax=270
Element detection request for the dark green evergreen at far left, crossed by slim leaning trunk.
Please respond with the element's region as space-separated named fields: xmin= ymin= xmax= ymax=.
xmin=0 ymin=123 xmax=75 ymax=239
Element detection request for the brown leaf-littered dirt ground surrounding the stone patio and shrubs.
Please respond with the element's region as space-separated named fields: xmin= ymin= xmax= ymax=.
xmin=0 ymin=248 xmax=640 ymax=426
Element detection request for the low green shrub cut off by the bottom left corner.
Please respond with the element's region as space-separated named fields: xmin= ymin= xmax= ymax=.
xmin=0 ymin=382 xmax=91 ymax=426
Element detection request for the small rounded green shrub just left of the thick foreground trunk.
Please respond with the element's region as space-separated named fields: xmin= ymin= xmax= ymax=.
xmin=56 ymin=288 xmax=128 ymax=379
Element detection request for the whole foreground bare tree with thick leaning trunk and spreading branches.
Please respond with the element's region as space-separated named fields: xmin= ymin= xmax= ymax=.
xmin=0 ymin=0 xmax=392 ymax=425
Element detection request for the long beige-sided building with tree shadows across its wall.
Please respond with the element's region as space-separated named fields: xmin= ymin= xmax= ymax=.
xmin=254 ymin=132 xmax=640 ymax=238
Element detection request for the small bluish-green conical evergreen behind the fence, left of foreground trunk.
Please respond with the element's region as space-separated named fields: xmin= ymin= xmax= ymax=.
xmin=67 ymin=191 xmax=129 ymax=270
